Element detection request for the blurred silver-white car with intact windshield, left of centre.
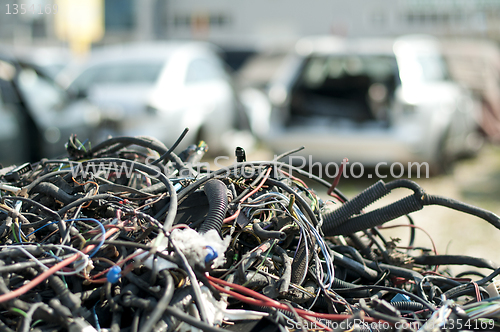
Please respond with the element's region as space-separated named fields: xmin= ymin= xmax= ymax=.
xmin=61 ymin=42 xmax=249 ymax=154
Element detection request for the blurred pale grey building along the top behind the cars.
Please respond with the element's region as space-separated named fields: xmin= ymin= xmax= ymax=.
xmin=0 ymin=0 xmax=500 ymax=49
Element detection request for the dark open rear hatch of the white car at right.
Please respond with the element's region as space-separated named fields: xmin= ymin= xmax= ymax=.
xmin=291 ymin=55 xmax=399 ymax=122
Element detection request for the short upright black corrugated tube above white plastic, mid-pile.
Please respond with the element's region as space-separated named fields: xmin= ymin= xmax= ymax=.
xmin=198 ymin=179 xmax=228 ymax=235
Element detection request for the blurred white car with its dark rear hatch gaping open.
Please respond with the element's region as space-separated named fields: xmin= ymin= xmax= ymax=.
xmin=250 ymin=36 xmax=483 ymax=171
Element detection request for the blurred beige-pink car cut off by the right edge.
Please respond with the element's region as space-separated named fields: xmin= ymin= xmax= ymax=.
xmin=442 ymin=39 xmax=500 ymax=143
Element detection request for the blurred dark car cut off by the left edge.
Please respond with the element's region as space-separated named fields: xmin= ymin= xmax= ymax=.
xmin=0 ymin=55 xmax=100 ymax=165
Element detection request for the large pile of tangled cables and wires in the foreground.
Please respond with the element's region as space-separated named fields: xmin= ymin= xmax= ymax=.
xmin=0 ymin=137 xmax=500 ymax=332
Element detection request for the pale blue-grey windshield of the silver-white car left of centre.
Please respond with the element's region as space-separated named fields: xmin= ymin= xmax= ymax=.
xmin=71 ymin=61 xmax=165 ymax=89
